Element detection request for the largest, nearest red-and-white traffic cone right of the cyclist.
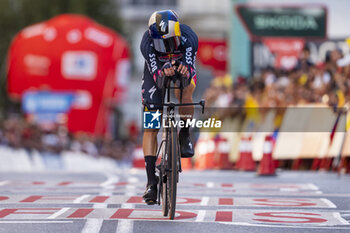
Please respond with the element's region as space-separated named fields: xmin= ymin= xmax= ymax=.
xmin=258 ymin=135 xmax=276 ymax=176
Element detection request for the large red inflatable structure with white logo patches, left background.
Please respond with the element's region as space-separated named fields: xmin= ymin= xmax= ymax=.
xmin=7 ymin=14 xmax=129 ymax=135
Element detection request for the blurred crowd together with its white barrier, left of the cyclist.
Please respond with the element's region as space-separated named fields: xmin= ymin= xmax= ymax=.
xmin=0 ymin=115 xmax=137 ymax=171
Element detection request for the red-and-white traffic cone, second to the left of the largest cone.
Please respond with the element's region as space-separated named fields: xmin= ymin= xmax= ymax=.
xmin=216 ymin=137 xmax=232 ymax=170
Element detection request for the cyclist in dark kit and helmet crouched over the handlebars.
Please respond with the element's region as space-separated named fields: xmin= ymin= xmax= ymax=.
xmin=140 ymin=10 xmax=198 ymax=204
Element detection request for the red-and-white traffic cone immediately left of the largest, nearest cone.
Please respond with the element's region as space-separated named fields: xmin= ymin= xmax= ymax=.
xmin=236 ymin=136 xmax=256 ymax=171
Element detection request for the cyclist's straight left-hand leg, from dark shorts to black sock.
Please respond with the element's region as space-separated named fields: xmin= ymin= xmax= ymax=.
xmin=142 ymin=67 xmax=162 ymax=186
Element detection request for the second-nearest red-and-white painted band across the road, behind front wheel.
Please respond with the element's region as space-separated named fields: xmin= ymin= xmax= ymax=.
xmin=0 ymin=195 xmax=336 ymax=209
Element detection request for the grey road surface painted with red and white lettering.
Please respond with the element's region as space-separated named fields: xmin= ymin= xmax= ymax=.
xmin=0 ymin=169 xmax=350 ymax=233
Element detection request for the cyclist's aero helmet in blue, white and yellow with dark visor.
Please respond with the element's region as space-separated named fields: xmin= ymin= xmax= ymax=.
xmin=148 ymin=10 xmax=181 ymax=53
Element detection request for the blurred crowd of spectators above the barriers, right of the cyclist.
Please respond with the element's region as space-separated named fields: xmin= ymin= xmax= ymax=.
xmin=204 ymin=46 xmax=350 ymax=131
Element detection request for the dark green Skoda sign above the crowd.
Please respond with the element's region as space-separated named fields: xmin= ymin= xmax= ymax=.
xmin=236 ymin=4 xmax=327 ymax=38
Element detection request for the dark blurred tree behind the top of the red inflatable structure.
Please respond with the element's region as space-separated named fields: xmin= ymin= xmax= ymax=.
xmin=0 ymin=0 xmax=123 ymax=114
